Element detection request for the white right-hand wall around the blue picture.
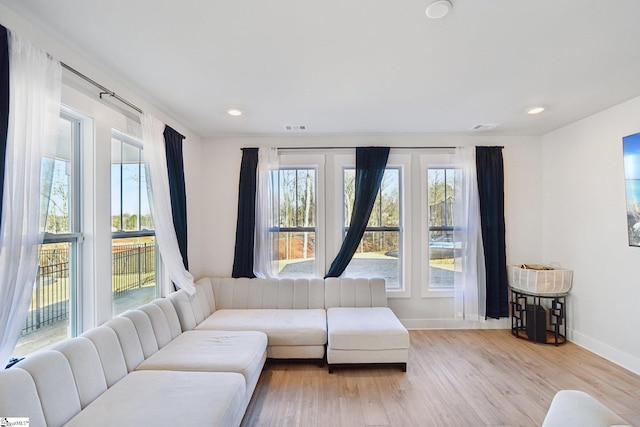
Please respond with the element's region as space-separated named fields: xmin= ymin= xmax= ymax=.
xmin=542 ymin=98 xmax=640 ymax=373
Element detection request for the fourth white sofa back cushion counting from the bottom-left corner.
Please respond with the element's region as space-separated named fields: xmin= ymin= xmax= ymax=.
xmin=81 ymin=326 xmax=127 ymax=387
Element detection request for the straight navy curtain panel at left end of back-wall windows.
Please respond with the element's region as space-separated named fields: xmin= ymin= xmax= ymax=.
xmin=231 ymin=148 xmax=258 ymax=277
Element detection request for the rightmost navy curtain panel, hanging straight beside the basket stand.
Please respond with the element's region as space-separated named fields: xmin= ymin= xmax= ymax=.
xmin=476 ymin=147 xmax=509 ymax=319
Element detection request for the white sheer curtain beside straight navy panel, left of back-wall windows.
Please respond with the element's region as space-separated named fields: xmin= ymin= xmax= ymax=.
xmin=253 ymin=148 xmax=280 ymax=278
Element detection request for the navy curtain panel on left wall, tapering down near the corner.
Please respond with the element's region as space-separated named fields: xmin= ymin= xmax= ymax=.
xmin=164 ymin=126 xmax=189 ymax=270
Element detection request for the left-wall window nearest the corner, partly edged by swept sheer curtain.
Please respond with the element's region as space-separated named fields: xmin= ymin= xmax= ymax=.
xmin=111 ymin=131 xmax=159 ymax=315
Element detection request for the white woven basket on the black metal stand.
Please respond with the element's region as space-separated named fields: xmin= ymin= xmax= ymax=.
xmin=508 ymin=264 xmax=573 ymax=295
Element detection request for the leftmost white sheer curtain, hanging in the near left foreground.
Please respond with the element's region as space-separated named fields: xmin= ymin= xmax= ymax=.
xmin=0 ymin=32 xmax=62 ymax=368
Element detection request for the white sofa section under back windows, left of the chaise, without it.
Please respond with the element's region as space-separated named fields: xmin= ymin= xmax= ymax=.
xmin=185 ymin=278 xmax=327 ymax=360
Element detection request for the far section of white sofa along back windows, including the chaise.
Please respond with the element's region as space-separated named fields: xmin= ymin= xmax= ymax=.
xmin=169 ymin=278 xmax=409 ymax=372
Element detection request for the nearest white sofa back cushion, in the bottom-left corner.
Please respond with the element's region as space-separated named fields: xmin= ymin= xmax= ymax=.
xmin=0 ymin=366 xmax=47 ymax=427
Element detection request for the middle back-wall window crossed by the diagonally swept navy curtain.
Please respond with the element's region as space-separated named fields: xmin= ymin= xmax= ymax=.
xmin=342 ymin=167 xmax=402 ymax=290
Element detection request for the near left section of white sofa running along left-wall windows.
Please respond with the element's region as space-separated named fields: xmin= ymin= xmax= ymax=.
xmin=0 ymin=299 xmax=267 ymax=427
